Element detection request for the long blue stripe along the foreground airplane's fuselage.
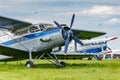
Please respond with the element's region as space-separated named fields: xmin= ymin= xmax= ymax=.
xmin=2 ymin=29 xmax=60 ymax=45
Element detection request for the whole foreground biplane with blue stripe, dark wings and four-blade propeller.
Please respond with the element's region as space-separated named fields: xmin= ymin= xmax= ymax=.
xmin=0 ymin=14 xmax=106 ymax=67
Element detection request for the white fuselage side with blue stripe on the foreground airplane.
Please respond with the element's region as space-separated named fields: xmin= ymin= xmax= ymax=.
xmin=0 ymin=29 xmax=64 ymax=52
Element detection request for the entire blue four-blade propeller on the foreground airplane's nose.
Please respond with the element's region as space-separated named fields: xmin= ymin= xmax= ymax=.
xmin=54 ymin=14 xmax=83 ymax=55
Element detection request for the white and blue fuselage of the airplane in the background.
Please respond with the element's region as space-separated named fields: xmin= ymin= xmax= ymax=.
xmin=79 ymin=39 xmax=107 ymax=54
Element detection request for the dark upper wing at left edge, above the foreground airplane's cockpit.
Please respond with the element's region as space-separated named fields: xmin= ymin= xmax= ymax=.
xmin=0 ymin=16 xmax=32 ymax=30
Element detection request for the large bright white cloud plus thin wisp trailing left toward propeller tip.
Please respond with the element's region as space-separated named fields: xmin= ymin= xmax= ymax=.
xmin=61 ymin=5 xmax=120 ymax=17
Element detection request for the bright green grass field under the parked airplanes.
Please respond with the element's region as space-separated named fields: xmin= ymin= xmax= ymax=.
xmin=0 ymin=60 xmax=120 ymax=80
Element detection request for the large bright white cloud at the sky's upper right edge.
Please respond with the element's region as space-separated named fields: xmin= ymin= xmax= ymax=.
xmin=79 ymin=6 xmax=120 ymax=16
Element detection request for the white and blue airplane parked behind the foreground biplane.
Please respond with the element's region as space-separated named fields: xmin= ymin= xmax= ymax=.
xmin=54 ymin=37 xmax=117 ymax=60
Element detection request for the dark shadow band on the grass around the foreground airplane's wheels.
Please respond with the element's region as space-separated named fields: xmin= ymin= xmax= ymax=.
xmin=0 ymin=62 xmax=110 ymax=69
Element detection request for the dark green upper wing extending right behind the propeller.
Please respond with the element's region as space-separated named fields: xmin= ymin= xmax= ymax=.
xmin=72 ymin=29 xmax=106 ymax=39
